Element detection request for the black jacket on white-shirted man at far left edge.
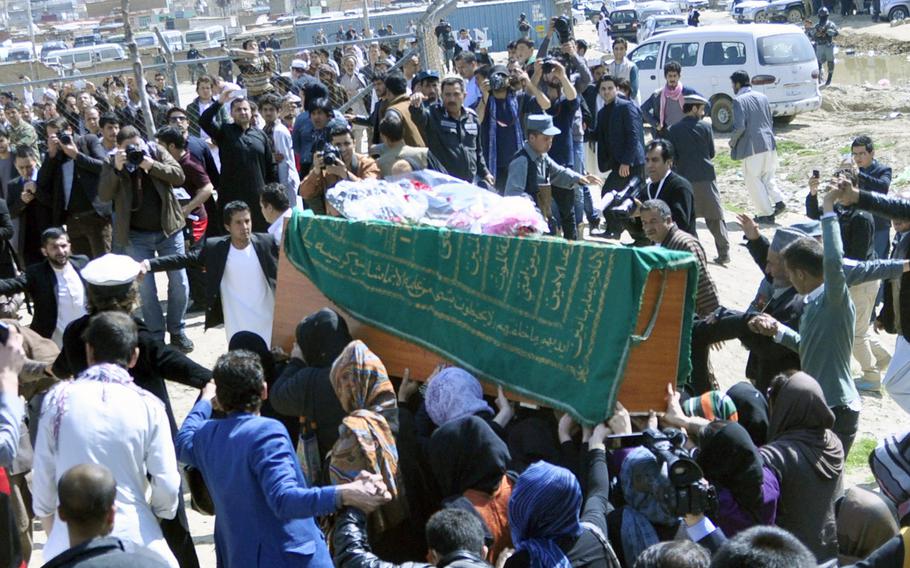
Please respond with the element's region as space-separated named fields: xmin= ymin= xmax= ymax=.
xmin=0 ymin=254 xmax=89 ymax=338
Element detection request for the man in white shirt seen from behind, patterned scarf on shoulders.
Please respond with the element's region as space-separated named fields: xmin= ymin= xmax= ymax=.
xmin=33 ymin=312 xmax=180 ymax=568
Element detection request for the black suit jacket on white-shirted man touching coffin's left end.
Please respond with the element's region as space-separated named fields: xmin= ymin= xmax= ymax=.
xmin=149 ymin=233 xmax=278 ymax=329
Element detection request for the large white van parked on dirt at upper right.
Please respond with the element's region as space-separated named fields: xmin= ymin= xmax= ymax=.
xmin=629 ymin=24 xmax=822 ymax=132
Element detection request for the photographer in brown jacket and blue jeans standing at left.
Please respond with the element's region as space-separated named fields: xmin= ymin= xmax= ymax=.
xmin=98 ymin=126 xmax=192 ymax=351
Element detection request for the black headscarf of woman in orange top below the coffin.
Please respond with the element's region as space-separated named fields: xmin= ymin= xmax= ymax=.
xmin=429 ymin=416 xmax=511 ymax=499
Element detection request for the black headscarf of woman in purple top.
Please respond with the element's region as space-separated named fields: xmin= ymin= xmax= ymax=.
xmin=697 ymin=420 xmax=764 ymax=517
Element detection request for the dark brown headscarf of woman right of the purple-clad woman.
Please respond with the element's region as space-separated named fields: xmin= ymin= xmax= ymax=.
xmin=762 ymin=372 xmax=844 ymax=479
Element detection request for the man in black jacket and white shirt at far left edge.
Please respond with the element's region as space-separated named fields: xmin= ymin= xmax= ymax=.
xmin=0 ymin=227 xmax=89 ymax=347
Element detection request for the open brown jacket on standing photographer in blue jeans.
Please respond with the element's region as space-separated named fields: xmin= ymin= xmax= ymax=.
xmin=98 ymin=143 xmax=185 ymax=247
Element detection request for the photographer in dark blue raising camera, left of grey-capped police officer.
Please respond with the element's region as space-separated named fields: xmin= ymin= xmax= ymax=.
xmin=477 ymin=64 xmax=550 ymax=195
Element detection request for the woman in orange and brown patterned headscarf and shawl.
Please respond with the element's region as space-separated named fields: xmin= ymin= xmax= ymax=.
xmin=329 ymin=340 xmax=408 ymax=556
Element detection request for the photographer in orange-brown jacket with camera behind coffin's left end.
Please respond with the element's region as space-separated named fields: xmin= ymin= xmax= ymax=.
xmin=300 ymin=126 xmax=379 ymax=215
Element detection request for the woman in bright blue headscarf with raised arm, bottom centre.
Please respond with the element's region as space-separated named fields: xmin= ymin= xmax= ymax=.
xmin=505 ymin=424 xmax=619 ymax=568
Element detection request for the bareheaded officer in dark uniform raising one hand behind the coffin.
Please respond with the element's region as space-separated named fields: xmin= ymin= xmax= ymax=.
xmin=411 ymin=77 xmax=494 ymax=188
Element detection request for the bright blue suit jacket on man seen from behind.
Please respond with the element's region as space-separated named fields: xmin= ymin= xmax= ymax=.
xmin=176 ymin=401 xmax=335 ymax=568
